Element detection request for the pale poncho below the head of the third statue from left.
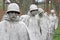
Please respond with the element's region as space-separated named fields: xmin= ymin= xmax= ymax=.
xmin=36 ymin=15 xmax=49 ymax=40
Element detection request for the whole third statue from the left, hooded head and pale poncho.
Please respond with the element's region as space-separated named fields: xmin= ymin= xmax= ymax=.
xmin=36 ymin=8 xmax=49 ymax=40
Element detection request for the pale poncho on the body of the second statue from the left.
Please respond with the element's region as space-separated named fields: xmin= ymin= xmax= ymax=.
xmin=27 ymin=17 xmax=41 ymax=40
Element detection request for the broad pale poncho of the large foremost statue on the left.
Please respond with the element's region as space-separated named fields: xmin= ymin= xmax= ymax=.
xmin=0 ymin=20 xmax=29 ymax=40
